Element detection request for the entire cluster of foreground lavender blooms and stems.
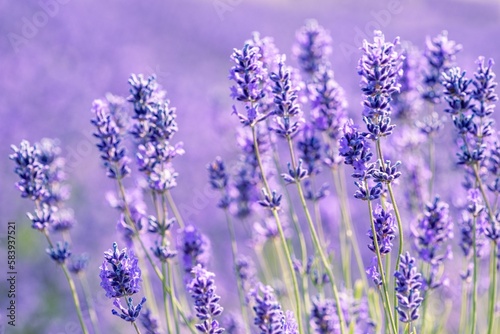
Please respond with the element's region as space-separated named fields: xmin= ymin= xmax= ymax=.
xmin=10 ymin=20 xmax=500 ymax=334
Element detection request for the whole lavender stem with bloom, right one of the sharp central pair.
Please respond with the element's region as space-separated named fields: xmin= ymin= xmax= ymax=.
xmin=270 ymin=56 xmax=346 ymax=333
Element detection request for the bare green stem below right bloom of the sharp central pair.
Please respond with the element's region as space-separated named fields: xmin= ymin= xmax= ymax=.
xmin=287 ymin=136 xmax=347 ymax=334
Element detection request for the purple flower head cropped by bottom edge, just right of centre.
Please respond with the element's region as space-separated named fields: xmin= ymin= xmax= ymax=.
xmin=250 ymin=284 xmax=285 ymax=334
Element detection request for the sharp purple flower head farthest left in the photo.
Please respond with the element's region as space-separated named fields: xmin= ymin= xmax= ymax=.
xmin=9 ymin=140 xmax=48 ymax=201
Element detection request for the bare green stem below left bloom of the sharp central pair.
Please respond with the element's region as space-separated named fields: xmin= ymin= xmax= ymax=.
xmin=250 ymin=124 xmax=304 ymax=334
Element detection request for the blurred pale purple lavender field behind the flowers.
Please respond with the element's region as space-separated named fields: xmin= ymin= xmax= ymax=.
xmin=0 ymin=0 xmax=500 ymax=334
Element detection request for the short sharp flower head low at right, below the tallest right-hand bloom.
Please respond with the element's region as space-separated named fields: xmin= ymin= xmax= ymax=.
xmin=394 ymin=252 xmax=423 ymax=323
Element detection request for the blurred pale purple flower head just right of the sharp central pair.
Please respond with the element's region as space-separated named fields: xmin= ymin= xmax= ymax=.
xmin=309 ymin=68 xmax=347 ymax=141
